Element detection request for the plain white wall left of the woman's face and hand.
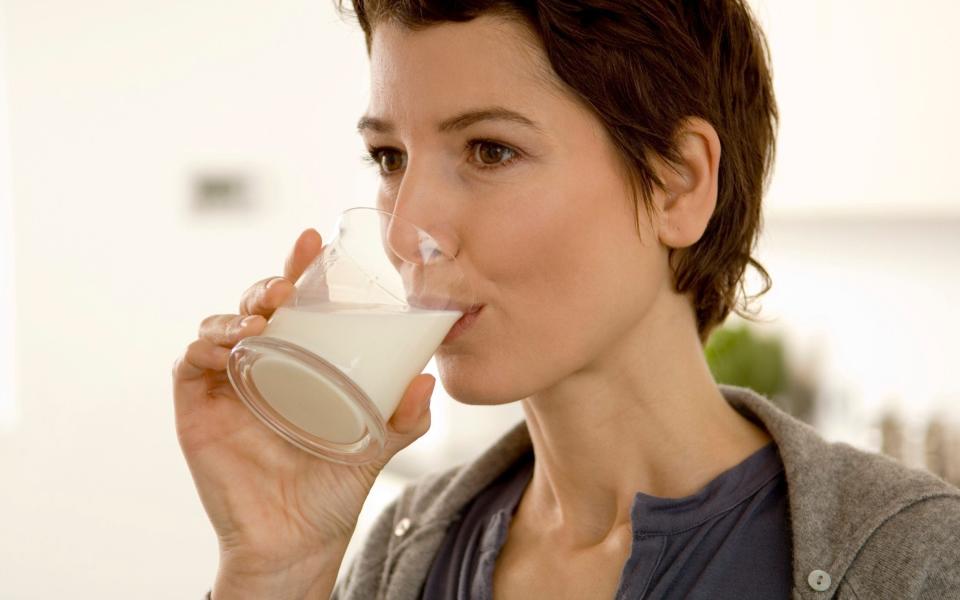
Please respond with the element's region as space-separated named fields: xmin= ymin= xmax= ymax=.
xmin=0 ymin=0 xmax=378 ymax=600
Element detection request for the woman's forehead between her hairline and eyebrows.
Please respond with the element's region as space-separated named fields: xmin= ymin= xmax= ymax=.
xmin=368 ymin=16 xmax=557 ymax=115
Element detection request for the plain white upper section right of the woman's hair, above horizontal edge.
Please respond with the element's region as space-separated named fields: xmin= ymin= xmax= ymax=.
xmin=751 ymin=0 xmax=960 ymax=216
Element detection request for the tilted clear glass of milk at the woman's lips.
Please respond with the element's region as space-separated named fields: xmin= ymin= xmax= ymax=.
xmin=227 ymin=208 xmax=476 ymax=464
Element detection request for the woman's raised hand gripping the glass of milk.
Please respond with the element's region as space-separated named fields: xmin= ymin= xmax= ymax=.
xmin=173 ymin=229 xmax=436 ymax=597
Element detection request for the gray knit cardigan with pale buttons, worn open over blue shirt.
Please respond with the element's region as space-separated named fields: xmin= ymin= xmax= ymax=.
xmin=333 ymin=385 xmax=960 ymax=600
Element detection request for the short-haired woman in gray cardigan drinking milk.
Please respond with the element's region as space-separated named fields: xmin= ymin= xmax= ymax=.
xmin=174 ymin=0 xmax=960 ymax=600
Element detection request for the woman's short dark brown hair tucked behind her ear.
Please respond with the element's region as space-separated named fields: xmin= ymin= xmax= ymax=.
xmin=336 ymin=0 xmax=778 ymax=342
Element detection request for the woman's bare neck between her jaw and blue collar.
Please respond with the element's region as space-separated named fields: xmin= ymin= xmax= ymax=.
xmin=516 ymin=292 xmax=770 ymax=548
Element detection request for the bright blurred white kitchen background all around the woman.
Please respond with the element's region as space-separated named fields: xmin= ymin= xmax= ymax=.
xmin=0 ymin=0 xmax=960 ymax=600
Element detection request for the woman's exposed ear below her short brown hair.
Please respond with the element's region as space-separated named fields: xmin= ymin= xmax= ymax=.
xmin=654 ymin=117 xmax=720 ymax=248
